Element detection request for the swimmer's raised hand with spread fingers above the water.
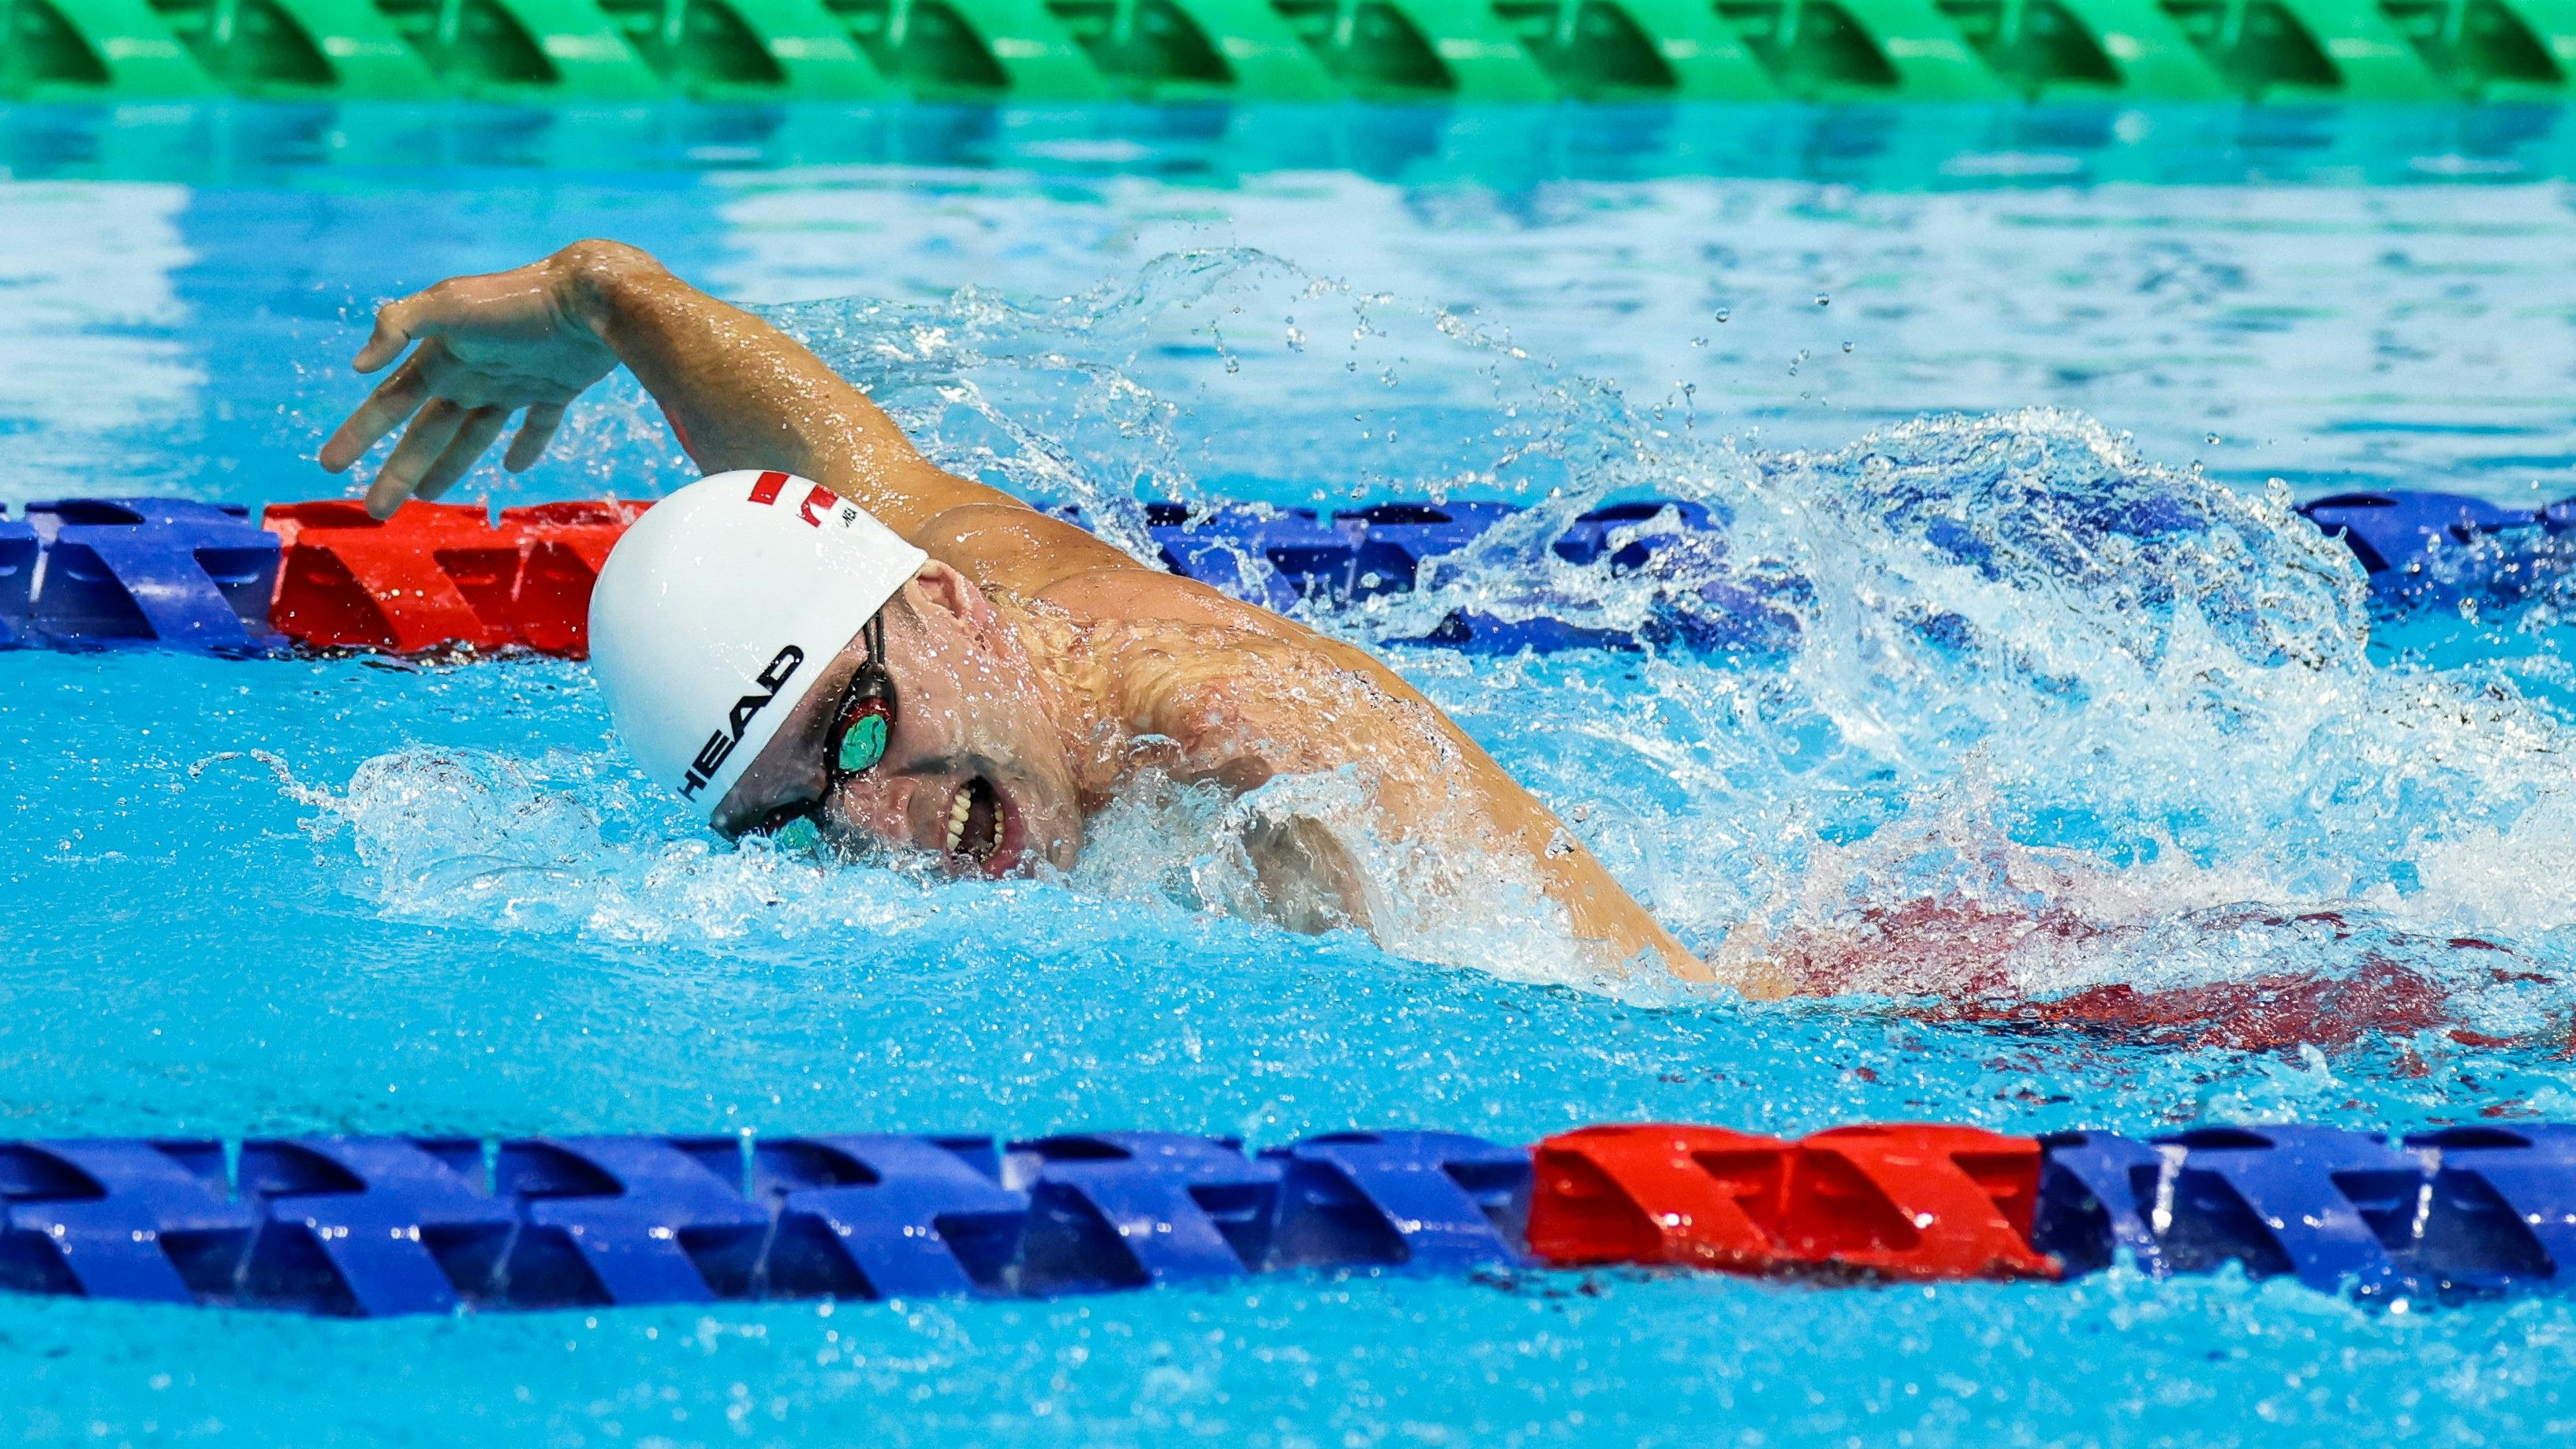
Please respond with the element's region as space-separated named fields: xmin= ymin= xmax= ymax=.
xmin=322 ymin=258 xmax=618 ymax=518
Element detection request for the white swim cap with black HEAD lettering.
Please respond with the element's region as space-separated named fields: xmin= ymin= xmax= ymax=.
xmin=590 ymin=472 xmax=930 ymax=817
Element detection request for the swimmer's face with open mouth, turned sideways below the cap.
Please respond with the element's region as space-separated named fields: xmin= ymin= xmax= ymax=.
xmin=716 ymin=562 xmax=1082 ymax=876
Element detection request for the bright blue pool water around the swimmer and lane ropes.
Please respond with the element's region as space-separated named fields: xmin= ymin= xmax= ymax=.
xmin=0 ymin=108 xmax=2576 ymax=1447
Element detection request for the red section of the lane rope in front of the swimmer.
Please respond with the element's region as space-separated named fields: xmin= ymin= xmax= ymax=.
xmin=1530 ymin=1124 xmax=2061 ymax=1279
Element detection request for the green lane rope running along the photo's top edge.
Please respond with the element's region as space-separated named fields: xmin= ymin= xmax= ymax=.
xmin=0 ymin=0 xmax=2576 ymax=103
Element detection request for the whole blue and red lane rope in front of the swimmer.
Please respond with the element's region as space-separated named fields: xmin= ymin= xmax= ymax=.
xmin=0 ymin=1126 xmax=2576 ymax=1317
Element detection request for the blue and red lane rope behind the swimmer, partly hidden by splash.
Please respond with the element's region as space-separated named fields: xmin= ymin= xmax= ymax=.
xmin=0 ymin=492 xmax=2452 ymax=658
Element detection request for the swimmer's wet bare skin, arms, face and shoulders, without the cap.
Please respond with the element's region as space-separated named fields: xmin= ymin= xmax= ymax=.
xmin=322 ymin=242 xmax=1775 ymax=995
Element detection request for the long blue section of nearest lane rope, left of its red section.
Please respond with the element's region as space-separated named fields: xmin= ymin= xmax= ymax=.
xmin=0 ymin=1132 xmax=1530 ymax=1317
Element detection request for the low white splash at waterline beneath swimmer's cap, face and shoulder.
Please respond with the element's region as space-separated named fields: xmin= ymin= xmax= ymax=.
xmin=312 ymin=750 xmax=1677 ymax=1000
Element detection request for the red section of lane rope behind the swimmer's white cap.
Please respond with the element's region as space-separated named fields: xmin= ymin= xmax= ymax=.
xmin=260 ymin=500 xmax=649 ymax=658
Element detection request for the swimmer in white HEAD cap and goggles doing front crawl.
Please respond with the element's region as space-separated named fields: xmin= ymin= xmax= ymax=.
xmin=319 ymin=242 xmax=1760 ymax=985
